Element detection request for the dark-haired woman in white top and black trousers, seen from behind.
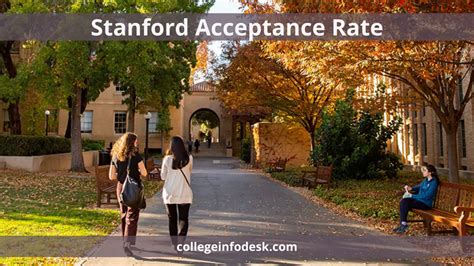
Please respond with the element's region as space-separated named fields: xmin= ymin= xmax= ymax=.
xmin=161 ymin=136 xmax=193 ymax=248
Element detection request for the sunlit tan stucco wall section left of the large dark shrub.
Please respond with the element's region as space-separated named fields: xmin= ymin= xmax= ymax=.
xmin=252 ymin=122 xmax=311 ymax=167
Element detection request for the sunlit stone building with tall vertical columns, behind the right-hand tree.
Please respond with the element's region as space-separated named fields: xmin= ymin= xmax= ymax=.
xmin=386 ymin=76 xmax=474 ymax=178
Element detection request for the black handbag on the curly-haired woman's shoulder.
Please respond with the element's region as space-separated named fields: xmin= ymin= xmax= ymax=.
xmin=120 ymin=158 xmax=146 ymax=209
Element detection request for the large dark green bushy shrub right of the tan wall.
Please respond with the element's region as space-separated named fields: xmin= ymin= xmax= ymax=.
xmin=311 ymin=91 xmax=403 ymax=179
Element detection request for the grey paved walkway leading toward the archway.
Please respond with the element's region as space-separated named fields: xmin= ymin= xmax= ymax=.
xmin=84 ymin=158 xmax=440 ymax=265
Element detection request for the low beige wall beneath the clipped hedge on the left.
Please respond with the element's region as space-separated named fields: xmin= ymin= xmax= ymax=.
xmin=0 ymin=151 xmax=99 ymax=172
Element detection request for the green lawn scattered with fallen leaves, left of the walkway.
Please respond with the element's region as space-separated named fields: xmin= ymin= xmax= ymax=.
xmin=0 ymin=170 xmax=162 ymax=264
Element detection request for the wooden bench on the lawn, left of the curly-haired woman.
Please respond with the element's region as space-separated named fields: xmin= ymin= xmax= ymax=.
xmin=95 ymin=165 xmax=119 ymax=207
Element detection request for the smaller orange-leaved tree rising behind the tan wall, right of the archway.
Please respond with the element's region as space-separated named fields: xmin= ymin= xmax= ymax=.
xmin=215 ymin=42 xmax=337 ymax=148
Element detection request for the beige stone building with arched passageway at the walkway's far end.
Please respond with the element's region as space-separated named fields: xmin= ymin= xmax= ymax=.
xmin=0 ymin=82 xmax=232 ymax=154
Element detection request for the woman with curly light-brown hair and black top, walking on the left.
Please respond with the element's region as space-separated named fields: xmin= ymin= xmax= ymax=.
xmin=109 ymin=132 xmax=147 ymax=256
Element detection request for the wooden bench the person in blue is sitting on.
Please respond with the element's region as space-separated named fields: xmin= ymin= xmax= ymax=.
xmin=411 ymin=182 xmax=474 ymax=236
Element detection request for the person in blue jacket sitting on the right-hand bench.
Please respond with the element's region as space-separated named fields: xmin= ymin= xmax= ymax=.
xmin=393 ymin=164 xmax=439 ymax=234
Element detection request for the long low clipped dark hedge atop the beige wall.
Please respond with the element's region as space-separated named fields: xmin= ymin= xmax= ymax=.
xmin=0 ymin=135 xmax=71 ymax=156
